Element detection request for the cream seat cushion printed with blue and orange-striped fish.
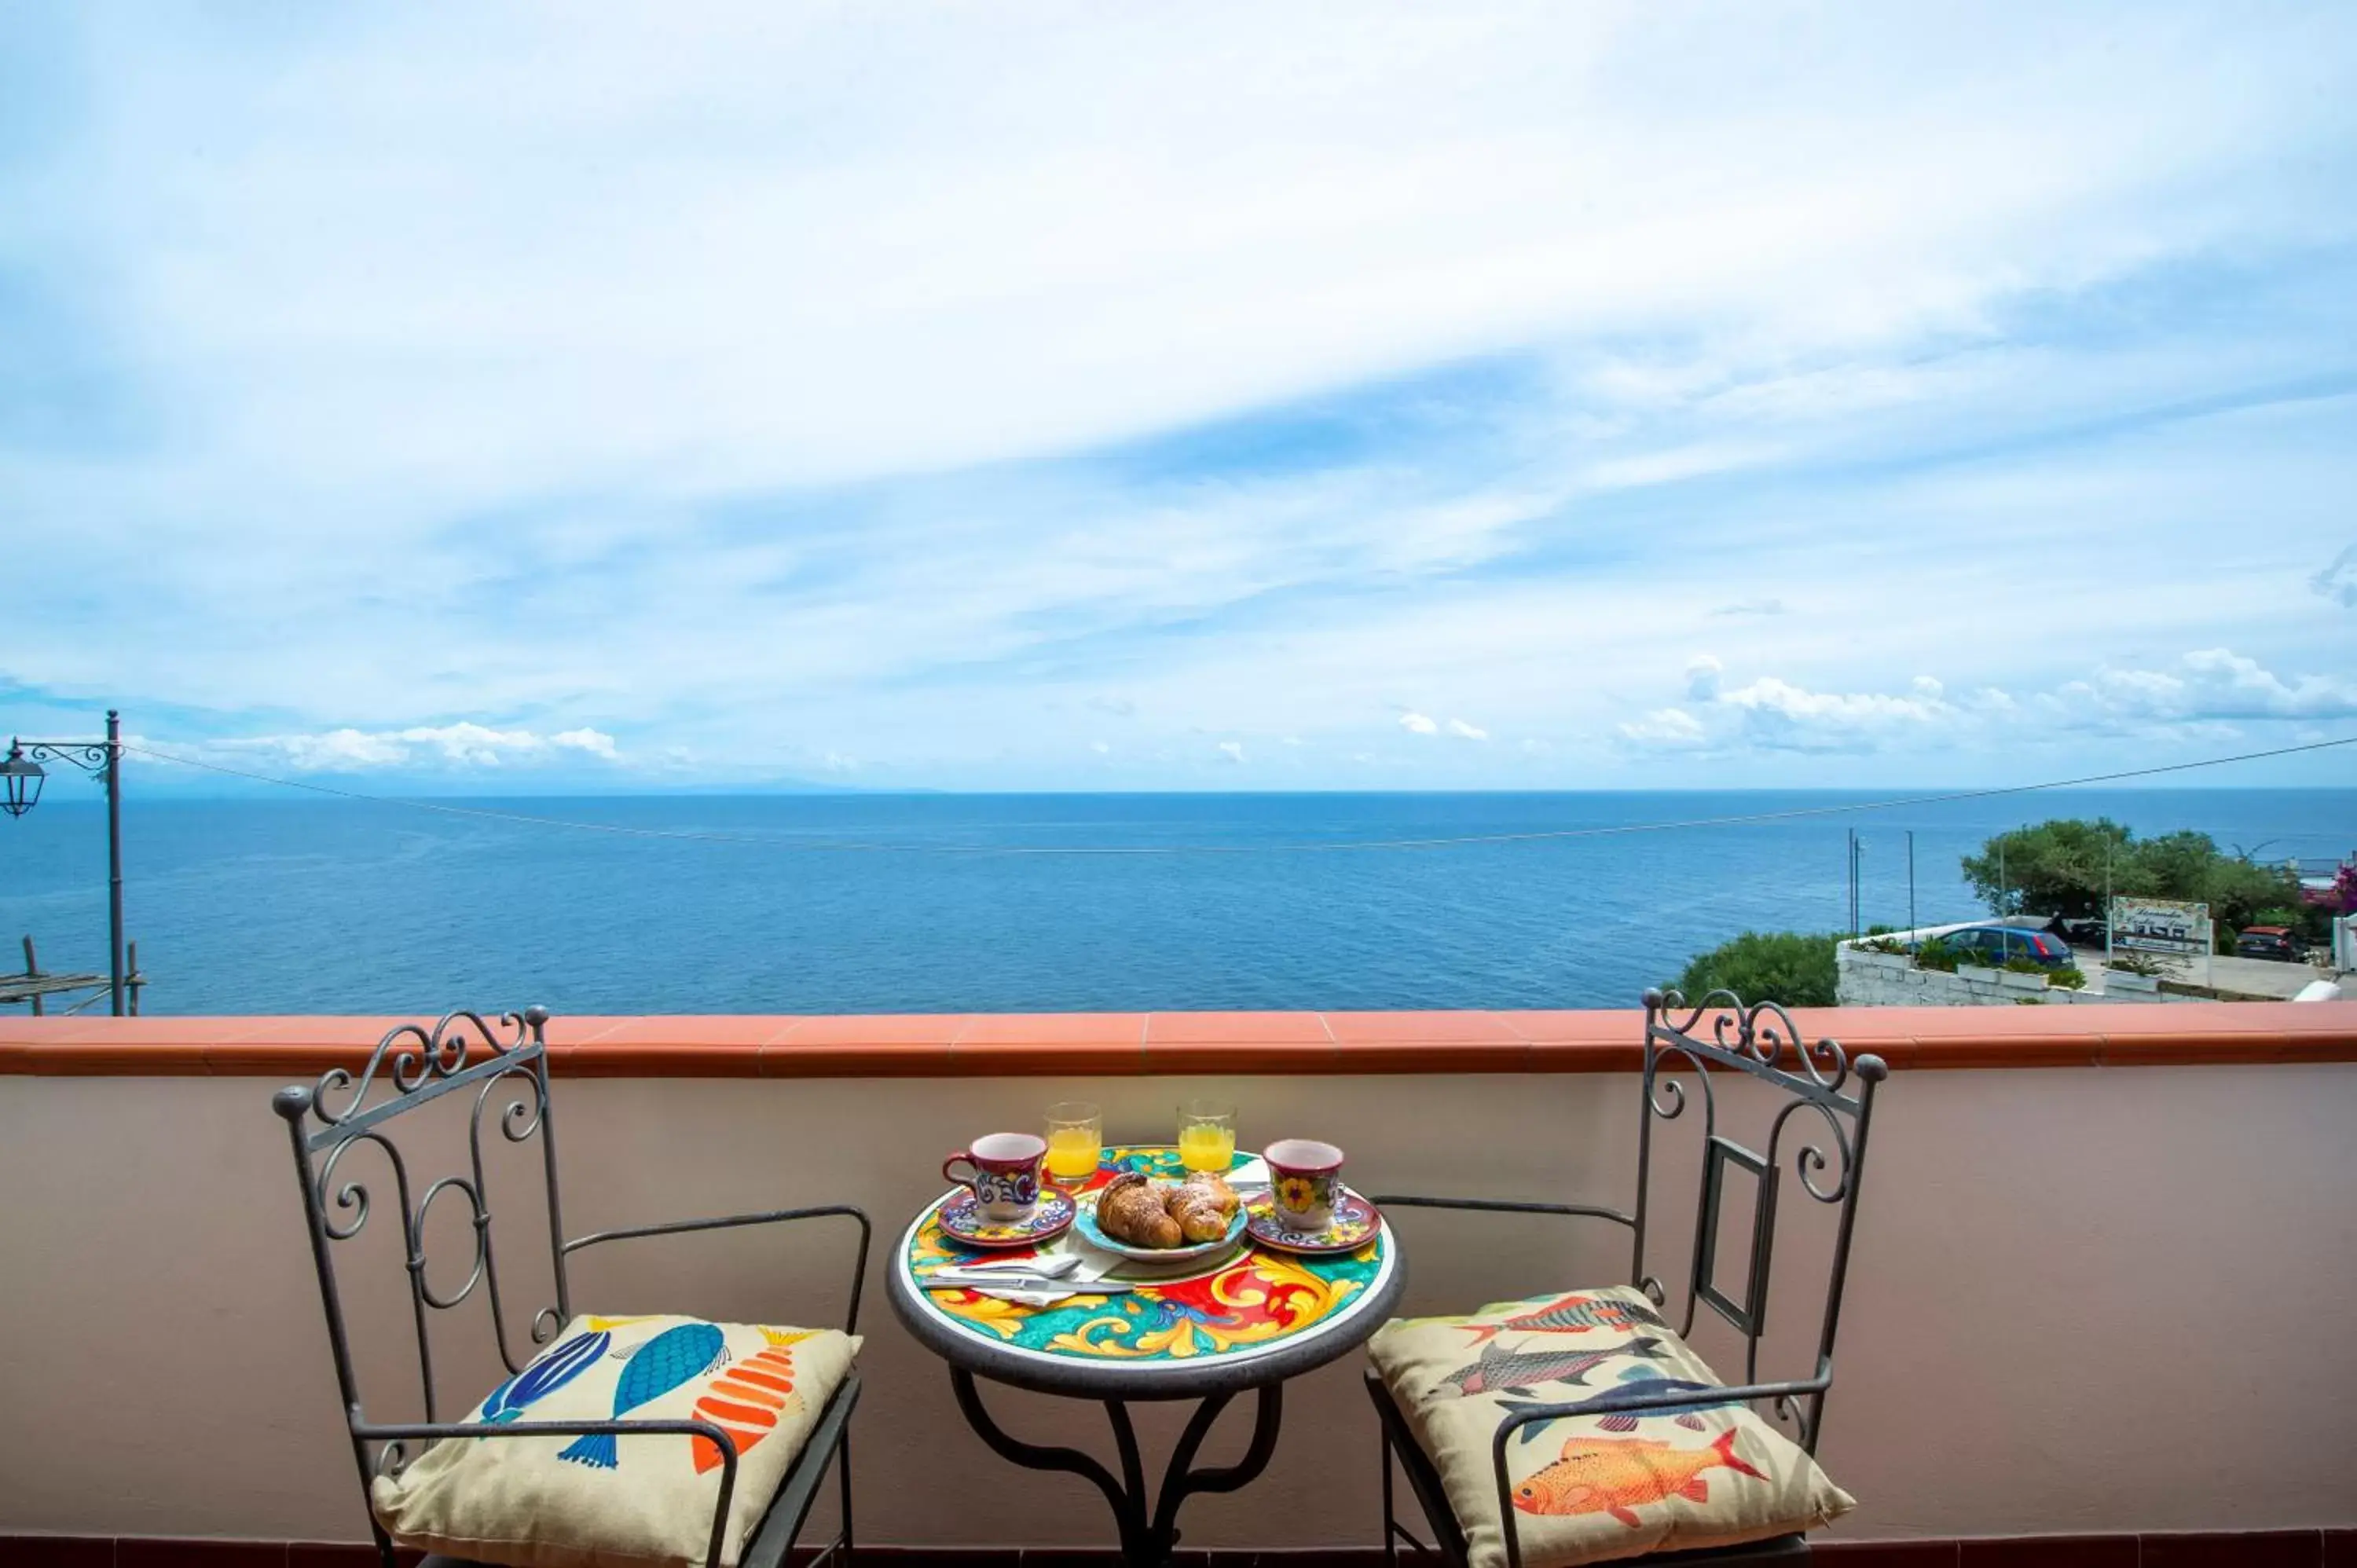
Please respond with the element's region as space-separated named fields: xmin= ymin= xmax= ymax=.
xmin=370 ymin=1318 xmax=860 ymax=1568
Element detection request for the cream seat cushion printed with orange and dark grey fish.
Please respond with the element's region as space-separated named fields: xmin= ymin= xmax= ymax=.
xmin=1367 ymin=1285 xmax=1857 ymax=1568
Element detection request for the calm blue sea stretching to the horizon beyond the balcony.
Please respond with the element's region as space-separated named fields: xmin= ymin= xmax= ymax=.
xmin=0 ymin=780 xmax=2357 ymax=1014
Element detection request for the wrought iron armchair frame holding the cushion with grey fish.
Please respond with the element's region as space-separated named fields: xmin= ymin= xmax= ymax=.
xmin=1367 ymin=991 xmax=1888 ymax=1568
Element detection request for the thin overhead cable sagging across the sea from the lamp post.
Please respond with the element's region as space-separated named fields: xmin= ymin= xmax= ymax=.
xmin=106 ymin=735 xmax=2357 ymax=856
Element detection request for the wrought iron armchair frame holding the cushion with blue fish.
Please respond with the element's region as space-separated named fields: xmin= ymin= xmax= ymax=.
xmin=271 ymin=1007 xmax=870 ymax=1568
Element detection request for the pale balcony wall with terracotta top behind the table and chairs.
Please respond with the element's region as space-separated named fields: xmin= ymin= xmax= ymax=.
xmin=0 ymin=1005 xmax=2357 ymax=1547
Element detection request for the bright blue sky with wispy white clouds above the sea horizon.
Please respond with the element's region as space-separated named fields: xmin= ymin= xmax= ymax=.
xmin=0 ymin=0 xmax=2357 ymax=793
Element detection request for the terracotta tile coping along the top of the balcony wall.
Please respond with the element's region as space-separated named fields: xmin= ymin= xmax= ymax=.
xmin=0 ymin=1002 xmax=2357 ymax=1080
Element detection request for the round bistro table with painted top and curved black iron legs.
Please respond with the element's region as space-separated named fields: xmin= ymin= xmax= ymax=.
xmin=889 ymin=1146 xmax=1405 ymax=1568
